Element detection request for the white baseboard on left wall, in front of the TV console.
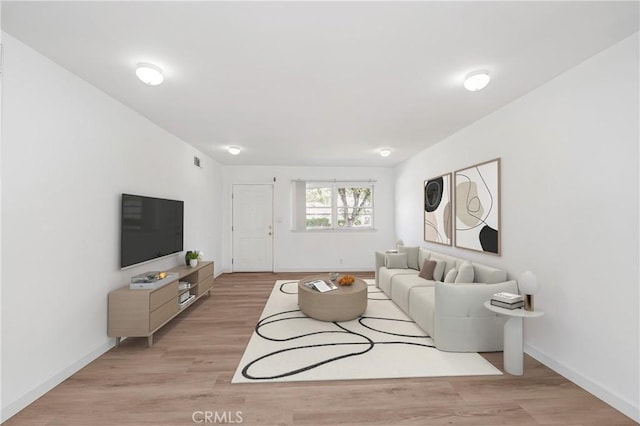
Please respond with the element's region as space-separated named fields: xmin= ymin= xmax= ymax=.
xmin=0 ymin=339 xmax=115 ymax=423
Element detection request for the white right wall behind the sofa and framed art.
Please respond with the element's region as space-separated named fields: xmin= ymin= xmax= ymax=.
xmin=396 ymin=34 xmax=640 ymax=421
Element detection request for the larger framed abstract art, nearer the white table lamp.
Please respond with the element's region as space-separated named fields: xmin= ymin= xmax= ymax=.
xmin=454 ymin=158 xmax=500 ymax=256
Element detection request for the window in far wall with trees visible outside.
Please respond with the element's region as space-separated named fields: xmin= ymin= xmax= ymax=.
xmin=296 ymin=182 xmax=373 ymax=230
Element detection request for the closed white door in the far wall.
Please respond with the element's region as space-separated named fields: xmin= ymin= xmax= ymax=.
xmin=231 ymin=185 xmax=273 ymax=272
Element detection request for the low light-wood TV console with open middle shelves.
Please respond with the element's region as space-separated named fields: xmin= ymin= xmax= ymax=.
xmin=107 ymin=262 xmax=213 ymax=347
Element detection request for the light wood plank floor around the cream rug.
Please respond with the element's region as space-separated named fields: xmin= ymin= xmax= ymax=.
xmin=6 ymin=273 xmax=635 ymax=425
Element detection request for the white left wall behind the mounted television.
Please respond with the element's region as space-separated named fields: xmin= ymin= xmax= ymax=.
xmin=1 ymin=34 xmax=222 ymax=420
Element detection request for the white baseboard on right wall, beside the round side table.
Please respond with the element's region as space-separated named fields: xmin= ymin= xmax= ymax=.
xmin=524 ymin=344 xmax=640 ymax=423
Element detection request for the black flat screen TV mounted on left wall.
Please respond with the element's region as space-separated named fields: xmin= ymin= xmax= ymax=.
xmin=120 ymin=194 xmax=184 ymax=268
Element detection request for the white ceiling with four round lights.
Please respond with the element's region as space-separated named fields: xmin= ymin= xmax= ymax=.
xmin=2 ymin=1 xmax=638 ymax=166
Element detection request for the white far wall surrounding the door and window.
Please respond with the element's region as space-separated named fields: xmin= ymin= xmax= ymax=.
xmin=223 ymin=166 xmax=395 ymax=272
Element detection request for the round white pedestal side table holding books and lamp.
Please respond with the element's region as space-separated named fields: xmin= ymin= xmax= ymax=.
xmin=484 ymin=301 xmax=544 ymax=376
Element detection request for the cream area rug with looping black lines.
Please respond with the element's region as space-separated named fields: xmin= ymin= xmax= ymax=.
xmin=231 ymin=280 xmax=502 ymax=383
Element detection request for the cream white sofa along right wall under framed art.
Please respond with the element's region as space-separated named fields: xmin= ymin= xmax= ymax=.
xmin=375 ymin=247 xmax=518 ymax=352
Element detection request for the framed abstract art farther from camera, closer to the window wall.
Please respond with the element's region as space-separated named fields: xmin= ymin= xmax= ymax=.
xmin=424 ymin=173 xmax=453 ymax=246
